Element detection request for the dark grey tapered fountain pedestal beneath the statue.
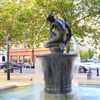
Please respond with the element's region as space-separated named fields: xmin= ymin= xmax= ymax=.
xmin=37 ymin=53 xmax=77 ymax=94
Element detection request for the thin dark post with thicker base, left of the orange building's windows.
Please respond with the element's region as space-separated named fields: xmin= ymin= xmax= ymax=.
xmin=7 ymin=37 xmax=10 ymax=80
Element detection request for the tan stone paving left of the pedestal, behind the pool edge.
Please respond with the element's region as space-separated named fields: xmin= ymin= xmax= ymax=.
xmin=0 ymin=68 xmax=43 ymax=90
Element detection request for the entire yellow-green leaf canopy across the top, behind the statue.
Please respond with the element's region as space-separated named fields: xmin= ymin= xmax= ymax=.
xmin=0 ymin=0 xmax=100 ymax=47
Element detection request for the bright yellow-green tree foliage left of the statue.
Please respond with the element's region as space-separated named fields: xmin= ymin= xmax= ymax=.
xmin=0 ymin=0 xmax=48 ymax=46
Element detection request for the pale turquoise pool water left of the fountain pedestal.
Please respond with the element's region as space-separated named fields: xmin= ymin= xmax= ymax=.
xmin=0 ymin=85 xmax=43 ymax=100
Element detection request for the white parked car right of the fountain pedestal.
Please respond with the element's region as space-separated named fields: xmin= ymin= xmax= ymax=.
xmin=79 ymin=62 xmax=100 ymax=73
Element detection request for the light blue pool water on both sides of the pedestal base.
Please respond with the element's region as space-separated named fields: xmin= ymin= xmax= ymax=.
xmin=0 ymin=84 xmax=100 ymax=100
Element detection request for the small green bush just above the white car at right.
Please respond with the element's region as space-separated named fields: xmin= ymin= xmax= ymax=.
xmin=79 ymin=49 xmax=94 ymax=60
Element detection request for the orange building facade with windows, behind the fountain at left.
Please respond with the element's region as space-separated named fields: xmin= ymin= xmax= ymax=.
xmin=9 ymin=48 xmax=50 ymax=63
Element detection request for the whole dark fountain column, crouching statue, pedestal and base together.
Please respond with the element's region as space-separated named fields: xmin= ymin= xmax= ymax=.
xmin=37 ymin=13 xmax=77 ymax=100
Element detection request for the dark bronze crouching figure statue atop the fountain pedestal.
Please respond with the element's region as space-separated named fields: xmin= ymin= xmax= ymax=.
xmin=45 ymin=13 xmax=72 ymax=53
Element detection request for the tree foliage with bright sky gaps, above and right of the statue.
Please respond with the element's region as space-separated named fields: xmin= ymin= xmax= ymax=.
xmin=36 ymin=0 xmax=100 ymax=52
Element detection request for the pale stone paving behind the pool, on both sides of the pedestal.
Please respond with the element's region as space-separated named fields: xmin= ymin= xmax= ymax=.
xmin=0 ymin=68 xmax=100 ymax=90
